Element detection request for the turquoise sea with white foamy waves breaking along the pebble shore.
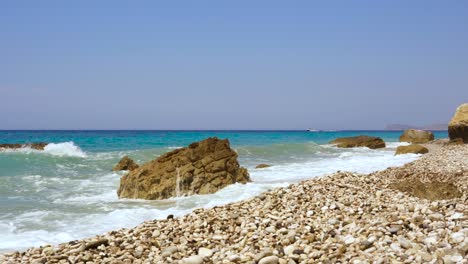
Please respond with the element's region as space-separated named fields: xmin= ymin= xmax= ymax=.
xmin=0 ymin=131 xmax=447 ymax=251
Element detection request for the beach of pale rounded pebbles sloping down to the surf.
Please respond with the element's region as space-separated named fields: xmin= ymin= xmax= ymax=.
xmin=0 ymin=145 xmax=468 ymax=263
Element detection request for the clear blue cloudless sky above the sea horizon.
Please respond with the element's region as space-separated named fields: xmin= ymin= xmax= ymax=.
xmin=0 ymin=0 xmax=468 ymax=129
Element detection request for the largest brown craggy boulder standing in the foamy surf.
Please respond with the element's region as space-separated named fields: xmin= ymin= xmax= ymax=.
xmin=117 ymin=138 xmax=250 ymax=200
